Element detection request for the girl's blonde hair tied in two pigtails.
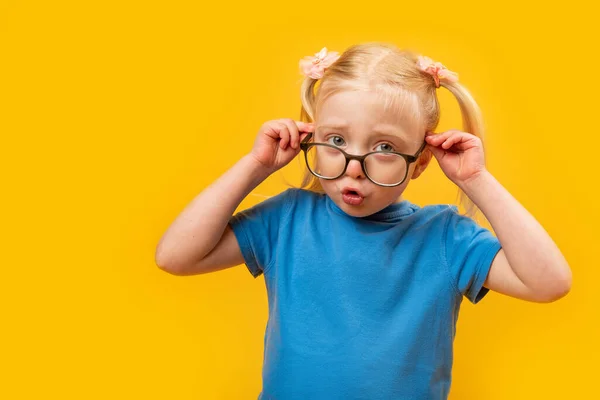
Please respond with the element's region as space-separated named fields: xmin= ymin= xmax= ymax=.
xmin=300 ymin=42 xmax=484 ymax=216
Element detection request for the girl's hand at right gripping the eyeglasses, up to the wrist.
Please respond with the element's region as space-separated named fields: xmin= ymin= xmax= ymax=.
xmin=425 ymin=130 xmax=485 ymax=187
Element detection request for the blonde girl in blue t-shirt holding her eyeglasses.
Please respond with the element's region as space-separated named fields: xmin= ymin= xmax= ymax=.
xmin=156 ymin=43 xmax=571 ymax=400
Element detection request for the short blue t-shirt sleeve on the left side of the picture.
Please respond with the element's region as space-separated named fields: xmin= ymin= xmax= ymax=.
xmin=229 ymin=189 xmax=293 ymax=278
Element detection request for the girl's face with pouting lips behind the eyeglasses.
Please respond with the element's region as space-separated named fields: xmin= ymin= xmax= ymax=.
xmin=313 ymin=91 xmax=431 ymax=217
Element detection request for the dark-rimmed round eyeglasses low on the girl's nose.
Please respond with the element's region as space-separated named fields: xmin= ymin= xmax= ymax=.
xmin=300 ymin=133 xmax=427 ymax=187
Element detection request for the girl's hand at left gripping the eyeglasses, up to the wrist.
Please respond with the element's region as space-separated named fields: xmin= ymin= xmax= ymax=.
xmin=251 ymin=118 xmax=314 ymax=173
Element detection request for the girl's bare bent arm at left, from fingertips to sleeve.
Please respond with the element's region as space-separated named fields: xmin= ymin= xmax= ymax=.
xmin=155 ymin=119 xmax=313 ymax=275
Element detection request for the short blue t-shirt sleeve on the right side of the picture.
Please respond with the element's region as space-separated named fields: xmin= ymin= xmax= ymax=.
xmin=444 ymin=208 xmax=502 ymax=304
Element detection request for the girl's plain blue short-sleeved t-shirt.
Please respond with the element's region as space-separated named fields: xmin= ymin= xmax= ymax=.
xmin=230 ymin=189 xmax=500 ymax=400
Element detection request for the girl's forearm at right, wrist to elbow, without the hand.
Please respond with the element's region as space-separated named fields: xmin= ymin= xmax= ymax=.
xmin=461 ymin=171 xmax=571 ymax=292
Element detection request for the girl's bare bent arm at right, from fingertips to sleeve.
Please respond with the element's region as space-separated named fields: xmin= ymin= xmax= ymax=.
xmin=426 ymin=130 xmax=571 ymax=302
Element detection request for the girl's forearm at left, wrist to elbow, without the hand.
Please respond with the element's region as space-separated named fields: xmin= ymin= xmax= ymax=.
xmin=156 ymin=155 xmax=269 ymax=266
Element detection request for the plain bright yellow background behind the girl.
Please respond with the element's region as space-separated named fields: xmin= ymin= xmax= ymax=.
xmin=0 ymin=0 xmax=600 ymax=399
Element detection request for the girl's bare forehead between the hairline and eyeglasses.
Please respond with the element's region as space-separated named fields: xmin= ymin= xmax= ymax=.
xmin=315 ymin=90 xmax=424 ymax=140
